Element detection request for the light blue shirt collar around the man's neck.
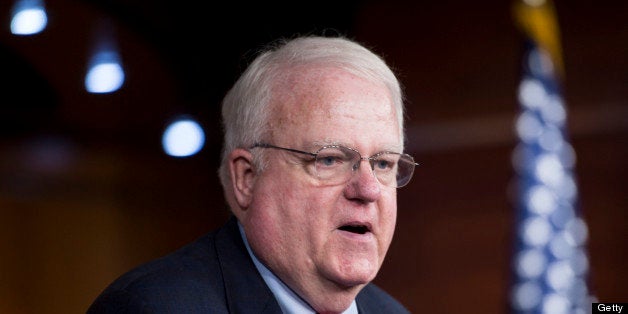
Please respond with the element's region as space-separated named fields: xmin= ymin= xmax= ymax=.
xmin=238 ymin=221 xmax=358 ymax=314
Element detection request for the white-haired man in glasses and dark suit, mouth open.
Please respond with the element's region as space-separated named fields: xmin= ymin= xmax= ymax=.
xmin=88 ymin=37 xmax=416 ymax=313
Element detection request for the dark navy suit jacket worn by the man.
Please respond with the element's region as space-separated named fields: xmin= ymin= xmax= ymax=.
xmin=87 ymin=217 xmax=407 ymax=313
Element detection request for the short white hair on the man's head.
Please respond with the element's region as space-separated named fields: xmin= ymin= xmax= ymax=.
xmin=219 ymin=36 xmax=404 ymax=189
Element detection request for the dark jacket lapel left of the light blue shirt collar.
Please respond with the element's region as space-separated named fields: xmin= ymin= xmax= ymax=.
xmin=215 ymin=217 xmax=281 ymax=314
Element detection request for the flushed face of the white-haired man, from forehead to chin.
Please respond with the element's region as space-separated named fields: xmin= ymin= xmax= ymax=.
xmin=242 ymin=68 xmax=402 ymax=302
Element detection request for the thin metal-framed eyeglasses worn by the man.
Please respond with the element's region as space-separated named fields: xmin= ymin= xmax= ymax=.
xmin=250 ymin=143 xmax=419 ymax=188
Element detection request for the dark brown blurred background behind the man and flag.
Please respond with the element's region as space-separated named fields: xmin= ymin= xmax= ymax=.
xmin=0 ymin=0 xmax=628 ymax=313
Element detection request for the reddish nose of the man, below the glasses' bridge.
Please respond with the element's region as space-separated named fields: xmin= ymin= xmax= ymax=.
xmin=345 ymin=159 xmax=382 ymax=203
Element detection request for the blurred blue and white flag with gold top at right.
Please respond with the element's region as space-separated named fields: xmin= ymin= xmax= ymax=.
xmin=509 ymin=1 xmax=592 ymax=314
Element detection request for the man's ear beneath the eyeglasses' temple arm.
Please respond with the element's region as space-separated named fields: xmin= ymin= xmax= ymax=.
xmin=229 ymin=148 xmax=257 ymax=210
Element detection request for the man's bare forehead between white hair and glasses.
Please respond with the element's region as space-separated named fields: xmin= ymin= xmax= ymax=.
xmin=271 ymin=66 xmax=400 ymax=150
